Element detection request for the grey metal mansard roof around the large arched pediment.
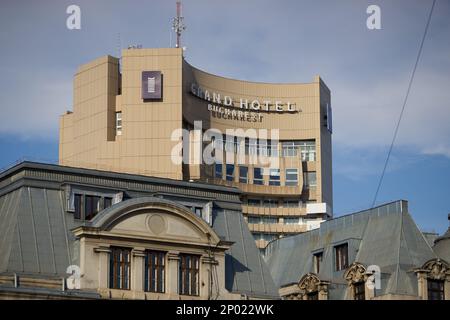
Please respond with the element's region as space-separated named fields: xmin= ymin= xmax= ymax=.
xmin=0 ymin=163 xmax=279 ymax=298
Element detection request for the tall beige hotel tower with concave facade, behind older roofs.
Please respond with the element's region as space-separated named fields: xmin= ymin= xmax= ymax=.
xmin=59 ymin=48 xmax=333 ymax=248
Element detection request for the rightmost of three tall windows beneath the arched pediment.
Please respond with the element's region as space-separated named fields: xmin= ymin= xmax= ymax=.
xmin=178 ymin=254 xmax=200 ymax=296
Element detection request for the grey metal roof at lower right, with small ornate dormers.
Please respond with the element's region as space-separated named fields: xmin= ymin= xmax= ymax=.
xmin=266 ymin=200 xmax=436 ymax=299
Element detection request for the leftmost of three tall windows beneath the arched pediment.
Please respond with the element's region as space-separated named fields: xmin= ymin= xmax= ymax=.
xmin=109 ymin=247 xmax=131 ymax=290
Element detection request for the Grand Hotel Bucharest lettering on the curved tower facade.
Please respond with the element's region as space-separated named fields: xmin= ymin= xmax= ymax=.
xmin=191 ymin=83 xmax=299 ymax=122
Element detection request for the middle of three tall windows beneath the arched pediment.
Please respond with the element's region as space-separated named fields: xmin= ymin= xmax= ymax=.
xmin=145 ymin=250 xmax=166 ymax=293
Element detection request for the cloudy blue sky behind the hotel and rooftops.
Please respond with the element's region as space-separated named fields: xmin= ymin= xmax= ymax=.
xmin=0 ymin=0 xmax=450 ymax=233
